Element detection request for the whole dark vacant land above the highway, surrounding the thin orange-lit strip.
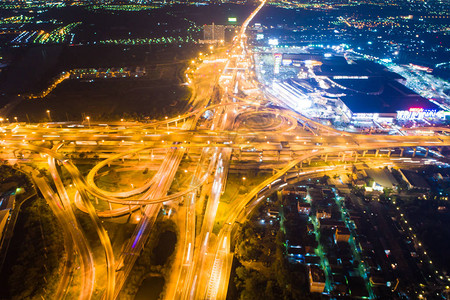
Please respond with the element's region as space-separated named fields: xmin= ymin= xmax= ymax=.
xmin=4 ymin=45 xmax=202 ymax=122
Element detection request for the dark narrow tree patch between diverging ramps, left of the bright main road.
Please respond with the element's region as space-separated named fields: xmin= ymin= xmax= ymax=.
xmin=119 ymin=220 xmax=178 ymax=300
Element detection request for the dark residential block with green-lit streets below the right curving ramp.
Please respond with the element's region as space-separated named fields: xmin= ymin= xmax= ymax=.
xmin=282 ymin=178 xmax=374 ymax=299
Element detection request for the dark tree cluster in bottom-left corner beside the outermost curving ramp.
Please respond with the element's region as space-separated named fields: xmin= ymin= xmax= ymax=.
xmin=0 ymin=197 xmax=64 ymax=299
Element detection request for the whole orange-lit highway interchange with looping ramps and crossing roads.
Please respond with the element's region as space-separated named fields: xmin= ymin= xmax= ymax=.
xmin=0 ymin=1 xmax=450 ymax=299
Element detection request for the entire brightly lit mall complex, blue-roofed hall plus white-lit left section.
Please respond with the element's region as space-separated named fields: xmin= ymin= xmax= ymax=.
xmin=273 ymin=52 xmax=442 ymax=124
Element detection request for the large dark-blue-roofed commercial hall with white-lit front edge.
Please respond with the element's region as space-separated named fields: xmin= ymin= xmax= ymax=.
xmin=313 ymin=57 xmax=440 ymax=122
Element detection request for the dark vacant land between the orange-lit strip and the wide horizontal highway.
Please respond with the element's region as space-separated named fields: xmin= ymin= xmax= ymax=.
xmin=10 ymin=67 xmax=190 ymax=122
